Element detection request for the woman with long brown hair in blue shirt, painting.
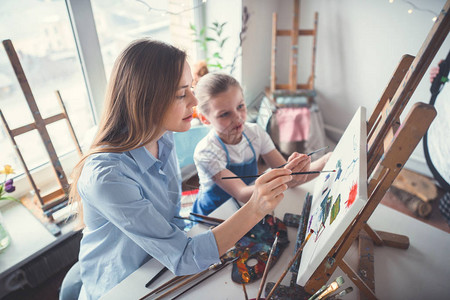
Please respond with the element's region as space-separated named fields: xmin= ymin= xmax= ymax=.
xmin=70 ymin=39 xmax=292 ymax=299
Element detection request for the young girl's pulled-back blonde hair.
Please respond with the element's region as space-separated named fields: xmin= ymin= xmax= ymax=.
xmin=195 ymin=73 xmax=242 ymax=114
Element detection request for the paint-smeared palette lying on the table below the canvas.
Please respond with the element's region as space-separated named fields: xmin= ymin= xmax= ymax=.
xmin=231 ymin=215 xmax=289 ymax=284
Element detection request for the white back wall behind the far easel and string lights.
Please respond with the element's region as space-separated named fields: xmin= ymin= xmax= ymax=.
xmin=242 ymin=0 xmax=450 ymax=176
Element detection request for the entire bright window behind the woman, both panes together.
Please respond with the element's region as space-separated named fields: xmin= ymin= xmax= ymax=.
xmin=0 ymin=0 xmax=204 ymax=202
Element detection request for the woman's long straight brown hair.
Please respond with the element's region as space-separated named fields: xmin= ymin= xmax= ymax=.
xmin=69 ymin=39 xmax=186 ymax=223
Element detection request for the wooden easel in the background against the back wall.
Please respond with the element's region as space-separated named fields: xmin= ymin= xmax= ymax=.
xmin=266 ymin=0 xmax=319 ymax=107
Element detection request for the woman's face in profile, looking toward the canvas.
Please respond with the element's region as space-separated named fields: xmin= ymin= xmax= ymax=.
xmin=162 ymin=62 xmax=198 ymax=132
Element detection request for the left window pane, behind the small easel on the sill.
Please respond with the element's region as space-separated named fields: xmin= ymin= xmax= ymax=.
xmin=0 ymin=0 xmax=94 ymax=198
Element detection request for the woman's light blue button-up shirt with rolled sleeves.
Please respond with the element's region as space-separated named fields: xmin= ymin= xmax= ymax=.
xmin=77 ymin=132 xmax=219 ymax=299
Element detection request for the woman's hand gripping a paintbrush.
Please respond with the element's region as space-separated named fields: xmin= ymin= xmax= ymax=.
xmin=248 ymin=168 xmax=292 ymax=218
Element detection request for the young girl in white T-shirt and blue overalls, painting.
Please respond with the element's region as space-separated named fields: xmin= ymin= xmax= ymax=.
xmin=193 ymin=73 xmax=331 ymax=215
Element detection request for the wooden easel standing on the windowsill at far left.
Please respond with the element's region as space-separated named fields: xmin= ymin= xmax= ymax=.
xmin=0 ymin=40 xmax=82 ymax=235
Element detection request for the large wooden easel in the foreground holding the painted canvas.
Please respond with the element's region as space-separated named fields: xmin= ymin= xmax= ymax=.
xmin=304 ymin=0 xmax=450 ymax=299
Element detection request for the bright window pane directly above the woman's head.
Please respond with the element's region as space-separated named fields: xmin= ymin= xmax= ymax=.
xmin=91 ymin=0 xmax=201 ymax=78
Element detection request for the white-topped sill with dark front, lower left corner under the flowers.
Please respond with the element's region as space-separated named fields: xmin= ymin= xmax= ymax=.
xmin=0 ymin=202 xmax=81 ymax=298
